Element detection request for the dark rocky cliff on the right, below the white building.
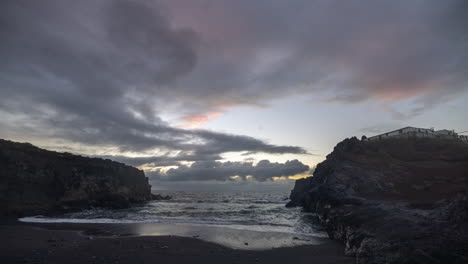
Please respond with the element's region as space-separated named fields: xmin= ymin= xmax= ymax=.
xmin=288 ymin=138 xmax=468 ymax=264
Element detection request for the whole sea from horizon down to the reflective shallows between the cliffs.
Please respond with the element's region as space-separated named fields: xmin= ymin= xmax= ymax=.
xmin=20 ymin=191 xmax=326 ymax=249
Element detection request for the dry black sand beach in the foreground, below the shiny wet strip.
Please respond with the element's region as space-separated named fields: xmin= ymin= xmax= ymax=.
xmin=0 ymin=222 xmax=353 ymax=264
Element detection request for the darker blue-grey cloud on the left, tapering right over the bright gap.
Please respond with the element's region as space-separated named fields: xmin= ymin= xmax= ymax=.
xmin=0 ymin=0 xmax=304 ymax=158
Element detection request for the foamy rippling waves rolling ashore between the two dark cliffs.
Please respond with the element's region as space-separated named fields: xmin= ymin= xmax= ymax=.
xmin=19 ymin=192 xmax=325 ymax=236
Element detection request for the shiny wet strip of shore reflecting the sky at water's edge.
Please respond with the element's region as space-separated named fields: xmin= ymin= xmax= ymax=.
xmin=18 ymin=214 xmax=329 ymax=250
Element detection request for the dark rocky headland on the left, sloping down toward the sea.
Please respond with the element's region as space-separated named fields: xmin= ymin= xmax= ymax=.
xmin=0 ymin=140 xmax=153 ymax=216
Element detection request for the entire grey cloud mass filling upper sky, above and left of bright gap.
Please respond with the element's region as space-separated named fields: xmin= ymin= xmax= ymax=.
xmin=0 ymin=0 xmax=468 ymax=157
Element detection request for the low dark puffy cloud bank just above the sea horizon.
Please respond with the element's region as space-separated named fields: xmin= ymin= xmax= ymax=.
xmin=152 ymin=160 xmax=309 ymax=181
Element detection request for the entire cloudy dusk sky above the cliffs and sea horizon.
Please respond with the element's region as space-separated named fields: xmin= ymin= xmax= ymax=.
xmin=0 ymin=0 xmax=468 ymax=189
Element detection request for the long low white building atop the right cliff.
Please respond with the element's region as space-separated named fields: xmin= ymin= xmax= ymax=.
xmin=366 ymin=127 xmax=468 ymax=143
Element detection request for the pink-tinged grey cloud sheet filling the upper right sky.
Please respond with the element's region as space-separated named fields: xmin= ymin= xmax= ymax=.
xmin=164 ymin=0 xmax=468 ymax=111
